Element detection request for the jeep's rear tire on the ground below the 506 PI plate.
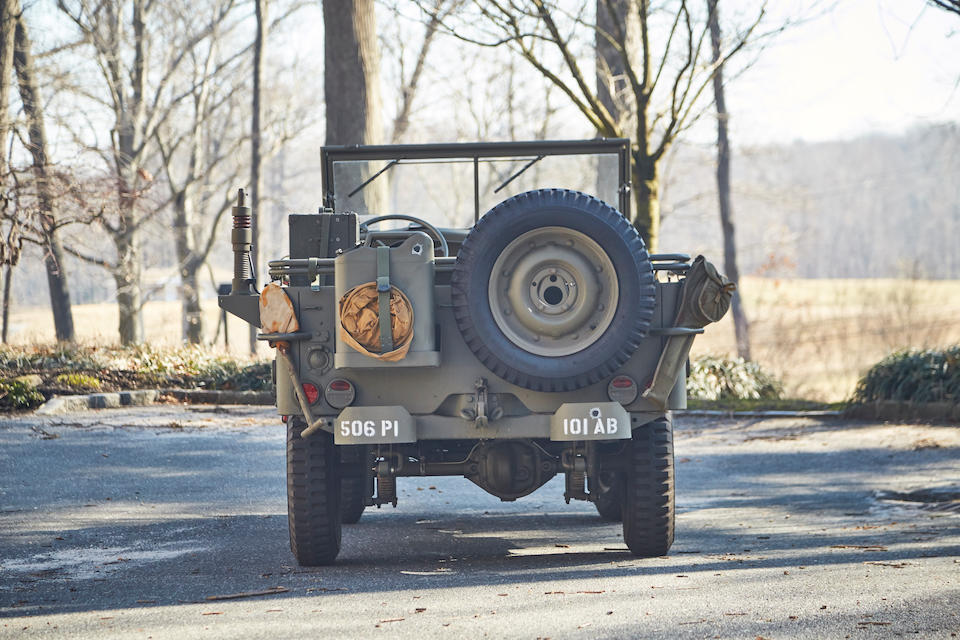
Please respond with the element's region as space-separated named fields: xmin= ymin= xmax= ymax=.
xmin=287 ymin=417 xmax=341 ymax=567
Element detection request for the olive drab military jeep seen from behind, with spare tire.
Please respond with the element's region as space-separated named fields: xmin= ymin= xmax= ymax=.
xmin=220 ymin=139 xmax=734 ymax=565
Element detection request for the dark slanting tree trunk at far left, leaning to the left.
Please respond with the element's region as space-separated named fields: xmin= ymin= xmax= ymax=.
xmin=14 ymin=7 xmax=75 ymax=342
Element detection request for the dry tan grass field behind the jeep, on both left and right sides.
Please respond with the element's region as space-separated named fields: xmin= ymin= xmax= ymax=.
xmin=11 ymin=277 xmax=960 ymax=402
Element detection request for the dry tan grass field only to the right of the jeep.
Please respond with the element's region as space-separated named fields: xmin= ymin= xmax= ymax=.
xmin=693 ymin=278 xmax=960 ymax=402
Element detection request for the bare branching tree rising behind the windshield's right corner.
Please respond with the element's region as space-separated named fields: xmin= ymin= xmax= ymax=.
xmin=421 ymin=0 xmax=764 ymax=250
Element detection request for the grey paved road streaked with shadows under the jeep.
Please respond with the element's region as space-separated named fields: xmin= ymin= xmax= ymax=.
xmin=0 ymin=406 xmax=960 ymax=639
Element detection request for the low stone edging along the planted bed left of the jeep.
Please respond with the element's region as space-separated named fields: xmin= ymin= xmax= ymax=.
xmin=34 ymin=389 xmax=274 ymax=416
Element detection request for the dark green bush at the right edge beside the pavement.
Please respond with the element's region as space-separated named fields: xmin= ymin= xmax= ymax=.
xmin=853 ymin=345 xmax=960 ymax=404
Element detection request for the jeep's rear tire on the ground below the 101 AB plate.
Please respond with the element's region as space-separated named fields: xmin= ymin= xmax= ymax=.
xmin=621 ymin=417 xmax=675 ymax=558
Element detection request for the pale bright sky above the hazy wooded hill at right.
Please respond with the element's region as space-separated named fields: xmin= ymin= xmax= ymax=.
xmin=724 ymin=0 xmax=960 ymax=144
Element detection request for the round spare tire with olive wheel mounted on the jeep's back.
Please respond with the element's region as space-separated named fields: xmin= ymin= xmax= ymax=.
xmin=451 ymin=189 xmax=655 ymax=391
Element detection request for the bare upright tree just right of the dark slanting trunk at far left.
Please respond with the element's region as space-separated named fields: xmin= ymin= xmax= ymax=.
xmin=57 ymin=0 xmax=234 ymax=344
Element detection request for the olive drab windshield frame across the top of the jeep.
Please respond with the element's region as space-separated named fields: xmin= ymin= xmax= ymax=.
xmin=320 ymin=138 xmax=631 ymax=222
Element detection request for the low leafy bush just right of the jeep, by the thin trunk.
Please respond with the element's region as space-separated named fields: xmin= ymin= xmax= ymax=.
xmin=687 ymin=356 xmax=783 ymax=400
